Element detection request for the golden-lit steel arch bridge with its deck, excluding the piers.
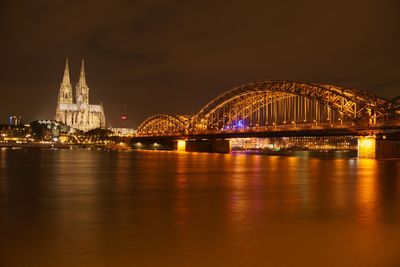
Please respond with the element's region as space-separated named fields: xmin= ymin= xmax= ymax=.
xmin=134 ymin=80 xmax=400 ymax=158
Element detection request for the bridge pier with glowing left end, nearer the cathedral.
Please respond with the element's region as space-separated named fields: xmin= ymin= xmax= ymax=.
xmin=177 ymin=139 xmax=231 ymax=153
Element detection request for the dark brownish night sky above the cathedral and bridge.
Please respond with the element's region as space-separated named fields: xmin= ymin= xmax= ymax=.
xmin=0 ymin=0 xmax=400 ymax=127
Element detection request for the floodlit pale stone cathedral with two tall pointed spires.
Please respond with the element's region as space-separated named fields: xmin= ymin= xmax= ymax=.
xmin=55 ymin=59 xmax=106 ymax=132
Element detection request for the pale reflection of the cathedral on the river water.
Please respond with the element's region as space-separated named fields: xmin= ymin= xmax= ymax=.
xmin=48 ymin=150 xmax=101 ymax=265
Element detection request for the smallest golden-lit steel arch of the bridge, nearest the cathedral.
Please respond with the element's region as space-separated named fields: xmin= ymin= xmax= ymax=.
xmin=137 ymin=114 xmax=189 ymax=136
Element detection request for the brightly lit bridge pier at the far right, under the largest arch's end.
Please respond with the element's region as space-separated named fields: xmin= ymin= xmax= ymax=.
xmin=358 ymin=136 xmax=400 ymax=159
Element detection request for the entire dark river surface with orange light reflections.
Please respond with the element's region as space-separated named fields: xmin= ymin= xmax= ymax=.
xmin=0 ymin=150 xmax=400 ymax=266
